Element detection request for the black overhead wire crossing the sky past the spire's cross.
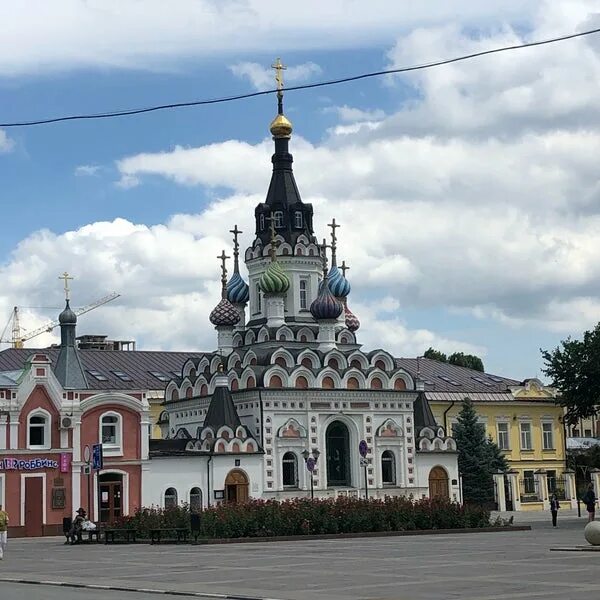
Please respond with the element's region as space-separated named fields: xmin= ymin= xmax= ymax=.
xmin=0 ymin=28 xmax=600 ymax=128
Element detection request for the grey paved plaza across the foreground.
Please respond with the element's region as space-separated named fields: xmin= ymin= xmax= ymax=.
xmin=0 ymin=513 xmax=600 ymax=600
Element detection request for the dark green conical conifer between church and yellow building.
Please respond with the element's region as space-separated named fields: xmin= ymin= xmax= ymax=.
xmin=454 ymin=398 xmax=508 ymax=504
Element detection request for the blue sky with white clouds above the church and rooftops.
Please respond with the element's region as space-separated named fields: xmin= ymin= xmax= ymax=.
xmin=0 ymin=0 xmax=600 ymax=379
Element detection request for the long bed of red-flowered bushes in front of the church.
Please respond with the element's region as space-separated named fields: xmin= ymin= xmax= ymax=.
xmin=112 ymin=497 xmax=490 ymax=539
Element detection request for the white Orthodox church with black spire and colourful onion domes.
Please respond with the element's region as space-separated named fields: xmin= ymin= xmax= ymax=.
xmin=142 ymin=65 xmax=460 ymax=506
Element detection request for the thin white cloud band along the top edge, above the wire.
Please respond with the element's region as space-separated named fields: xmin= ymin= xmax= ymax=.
xmin=0 ymin=0 xmax=538 ymax=76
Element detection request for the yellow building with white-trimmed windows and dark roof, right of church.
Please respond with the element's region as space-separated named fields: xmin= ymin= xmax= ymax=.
xmin=399 ymin=359 xmax=576 ymax=510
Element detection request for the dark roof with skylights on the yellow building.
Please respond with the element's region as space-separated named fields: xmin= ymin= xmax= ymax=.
xmin=396 ymin=358 xmax=521 ymax=393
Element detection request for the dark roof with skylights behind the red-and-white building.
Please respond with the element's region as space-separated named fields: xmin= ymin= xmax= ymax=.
xmin=0 ymin=348 xmax=207 ymax=390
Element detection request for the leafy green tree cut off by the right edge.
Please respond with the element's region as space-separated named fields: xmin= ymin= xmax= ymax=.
xmin=541 ymin=323 xmax=600 ymax=423
